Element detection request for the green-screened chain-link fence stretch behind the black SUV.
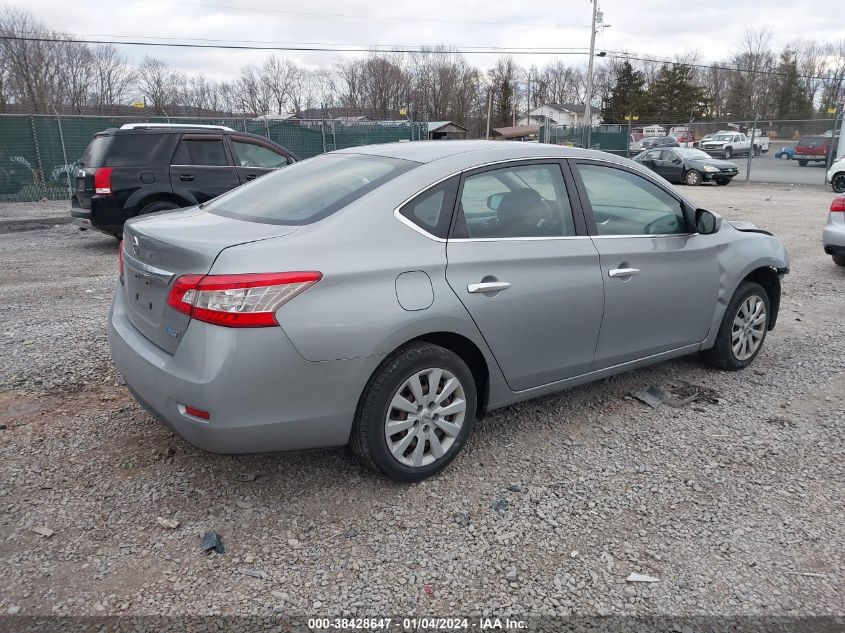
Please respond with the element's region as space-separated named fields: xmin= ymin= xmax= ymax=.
xmin=0 ymin=114 xmax=428 ymax=202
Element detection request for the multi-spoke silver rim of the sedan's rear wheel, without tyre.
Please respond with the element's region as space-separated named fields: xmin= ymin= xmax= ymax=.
xmin=384 ymin=367 xmax=467 ymax=468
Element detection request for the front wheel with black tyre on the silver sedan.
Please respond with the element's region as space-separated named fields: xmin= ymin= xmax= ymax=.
xmin=704 ymin=281 xmax=769 ymax=371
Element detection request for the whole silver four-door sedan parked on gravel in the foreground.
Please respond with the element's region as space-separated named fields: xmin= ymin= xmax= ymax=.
xmin=109 ymin=141 xmax=789 ymax=481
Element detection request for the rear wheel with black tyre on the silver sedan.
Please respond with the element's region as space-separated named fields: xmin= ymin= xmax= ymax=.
xmin=349 ymin=343 xmax=477 ymax=482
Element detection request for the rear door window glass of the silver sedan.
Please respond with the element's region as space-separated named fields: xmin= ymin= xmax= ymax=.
xmin=455 ymin=164 xmax=575 ymax=238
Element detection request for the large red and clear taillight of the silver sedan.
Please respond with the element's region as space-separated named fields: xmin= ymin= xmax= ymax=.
xmin=167 ymin=272 xmax=323 ymax=327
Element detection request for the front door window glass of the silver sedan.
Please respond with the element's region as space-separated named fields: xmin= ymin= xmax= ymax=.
xmin=578 ymin=164 xmax=688 ymax=235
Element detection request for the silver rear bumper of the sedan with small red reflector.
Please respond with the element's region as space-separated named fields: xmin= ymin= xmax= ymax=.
xmin=109 ymin=291 xmax=383 ymax=454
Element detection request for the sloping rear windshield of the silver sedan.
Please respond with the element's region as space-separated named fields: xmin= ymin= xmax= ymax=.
xmin=202 ymin=154 xmax=419 ymax=225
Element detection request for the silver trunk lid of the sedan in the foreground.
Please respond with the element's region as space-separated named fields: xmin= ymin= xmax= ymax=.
xmin=118 ymin=207 xmax=299 ymax=354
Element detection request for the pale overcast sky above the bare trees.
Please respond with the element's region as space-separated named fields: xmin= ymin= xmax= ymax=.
xmin=14 ymin=0 xmax=845 ymax=78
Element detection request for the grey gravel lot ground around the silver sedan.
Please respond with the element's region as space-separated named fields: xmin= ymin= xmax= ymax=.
xmin=0 ymin=183 xmax=845 ymax=616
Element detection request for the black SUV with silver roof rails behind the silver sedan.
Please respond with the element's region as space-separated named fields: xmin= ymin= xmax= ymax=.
xmin=70 ymin=123 xmax=299 ymax=239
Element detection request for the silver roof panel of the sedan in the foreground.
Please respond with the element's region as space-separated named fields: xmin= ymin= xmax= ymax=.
xmin=332 ymin=140 xmax=611 ymax=163
